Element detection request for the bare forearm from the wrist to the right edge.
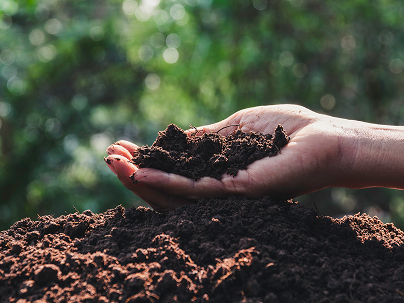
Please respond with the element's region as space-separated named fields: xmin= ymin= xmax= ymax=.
xmin=337 ymin=121 xmax=404 ymax=189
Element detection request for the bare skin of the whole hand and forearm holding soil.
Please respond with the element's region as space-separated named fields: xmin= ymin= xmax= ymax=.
xmin=106 ymin=105 xmax=404 ymax=212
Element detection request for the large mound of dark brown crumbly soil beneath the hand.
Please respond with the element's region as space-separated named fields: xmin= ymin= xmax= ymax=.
xmin=0 ymin=198 xmax=404 ymax=303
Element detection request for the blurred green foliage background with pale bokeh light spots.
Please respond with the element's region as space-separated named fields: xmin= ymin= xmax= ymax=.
xmin=0 ymin=0 xmax=404 ymax=230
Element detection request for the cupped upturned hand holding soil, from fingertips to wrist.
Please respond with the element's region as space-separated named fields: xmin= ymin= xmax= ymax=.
xmin=105 ymin=105 xmax=342 ymax=212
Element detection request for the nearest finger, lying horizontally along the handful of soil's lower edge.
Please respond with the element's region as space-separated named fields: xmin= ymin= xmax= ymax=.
xmin=134 ymin=168 xmax=228 ymax=199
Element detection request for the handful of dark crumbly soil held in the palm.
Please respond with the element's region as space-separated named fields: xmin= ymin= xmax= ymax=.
xmin=132 ymin=124 xmax=290 ymax=180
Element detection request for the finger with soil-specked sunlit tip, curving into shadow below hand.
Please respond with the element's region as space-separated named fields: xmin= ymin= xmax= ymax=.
xmin=106 ymin=155 xmax=195 ymax=212
